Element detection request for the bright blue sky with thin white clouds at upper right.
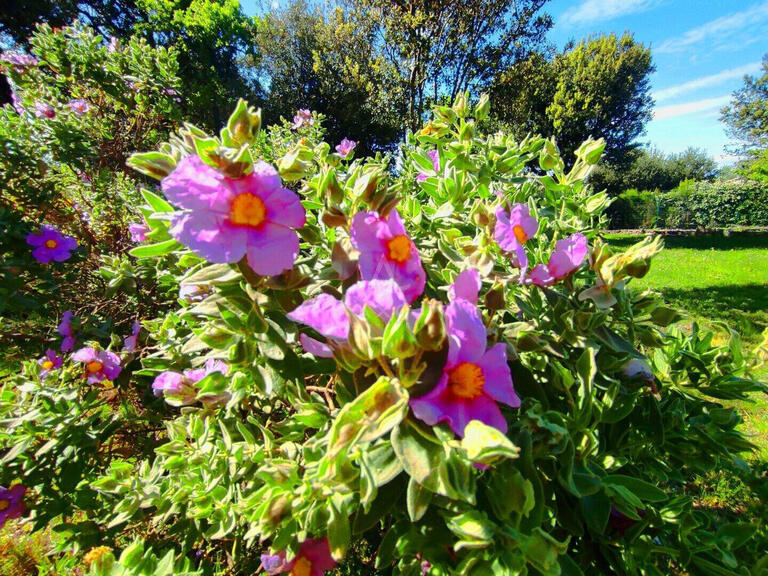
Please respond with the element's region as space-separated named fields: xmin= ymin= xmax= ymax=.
xmin=547 ymin=0 xmax=768 ymax=163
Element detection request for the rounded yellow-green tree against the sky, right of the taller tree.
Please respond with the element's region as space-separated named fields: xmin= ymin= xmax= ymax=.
xmin=491 ymin=34 xmax=654 ymax=163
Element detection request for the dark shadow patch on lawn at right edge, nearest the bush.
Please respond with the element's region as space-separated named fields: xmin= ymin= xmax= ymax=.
xmin=661 ymin=284 xmax=768 ymax=339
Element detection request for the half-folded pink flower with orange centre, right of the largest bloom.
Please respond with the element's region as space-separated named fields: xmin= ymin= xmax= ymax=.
xmin=349 ymin=210 xmax=427 ymax=302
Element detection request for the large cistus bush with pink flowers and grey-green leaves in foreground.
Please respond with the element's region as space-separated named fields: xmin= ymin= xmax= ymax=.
xmin=0 ymin=95 xmax=766 ymax=576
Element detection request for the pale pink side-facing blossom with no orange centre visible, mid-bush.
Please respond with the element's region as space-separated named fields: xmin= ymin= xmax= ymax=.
xmin=288 ymin=280 xmax=408 ymax=358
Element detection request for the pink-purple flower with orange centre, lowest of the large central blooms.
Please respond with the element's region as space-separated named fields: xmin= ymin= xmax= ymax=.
xmin=410 ymin=299 xmax=520 ymax=437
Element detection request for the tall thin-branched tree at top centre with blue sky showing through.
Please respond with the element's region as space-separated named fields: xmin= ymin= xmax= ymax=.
xmin=349 ymin=0 xmax=552 ymax=129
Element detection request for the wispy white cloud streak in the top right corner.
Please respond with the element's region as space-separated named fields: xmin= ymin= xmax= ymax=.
xmin=655 ymin=2 xmax=768 ymax=54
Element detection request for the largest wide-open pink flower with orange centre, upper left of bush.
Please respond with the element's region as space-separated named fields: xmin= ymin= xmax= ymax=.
xmin=162 ymin=156 xmax=306 ymax=276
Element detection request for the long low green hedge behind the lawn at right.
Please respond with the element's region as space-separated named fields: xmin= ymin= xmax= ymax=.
xmin=608 ymin=180 xmax=768 ymax=229
